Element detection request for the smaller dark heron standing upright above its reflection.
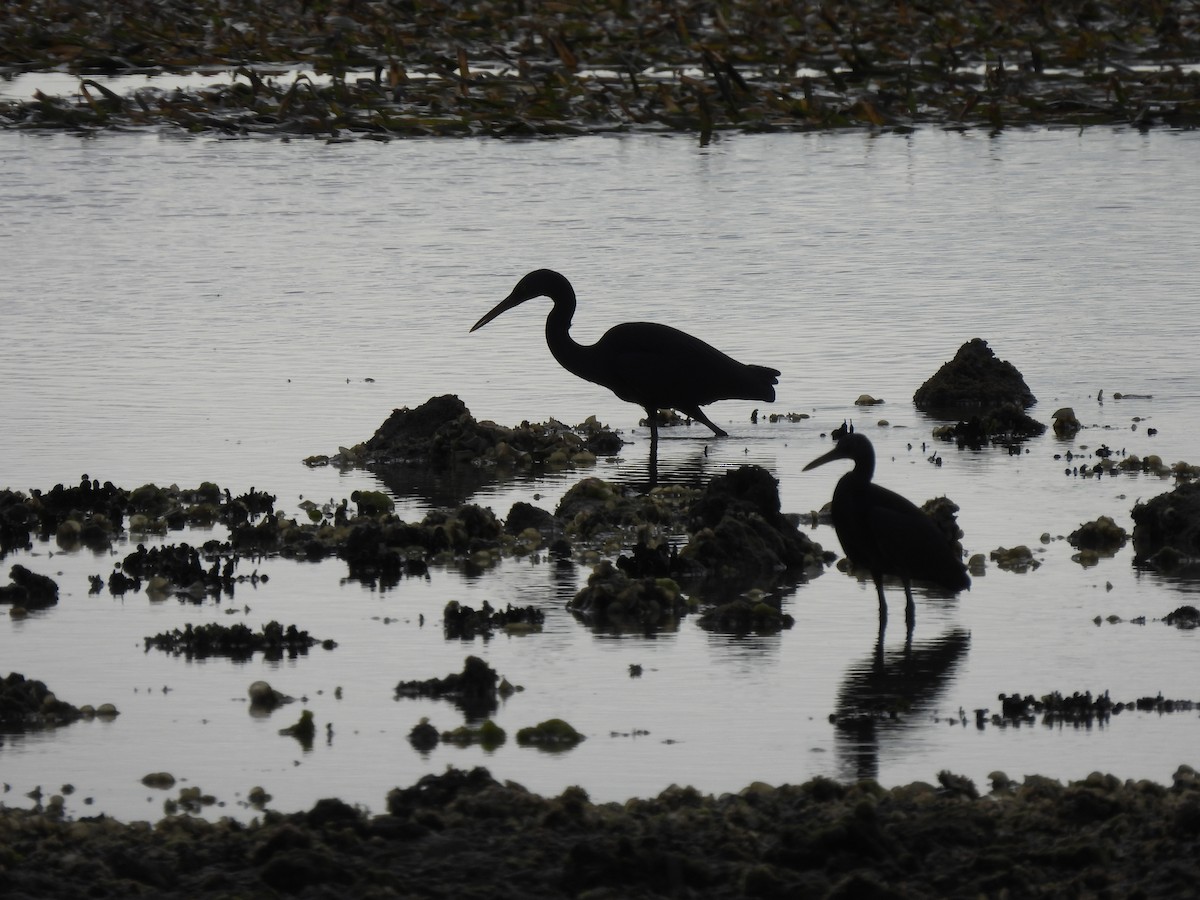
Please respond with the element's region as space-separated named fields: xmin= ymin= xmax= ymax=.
xmin=804 ymin=426 xmax=971 ymax=635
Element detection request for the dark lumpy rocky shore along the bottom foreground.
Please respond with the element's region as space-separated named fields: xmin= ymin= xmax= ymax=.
xmin=0 ymin=767 xmax=1200 ymax=900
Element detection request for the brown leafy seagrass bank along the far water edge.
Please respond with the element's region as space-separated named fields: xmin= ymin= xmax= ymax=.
xmin=0 ymin=0 xmax=1200 ymax=142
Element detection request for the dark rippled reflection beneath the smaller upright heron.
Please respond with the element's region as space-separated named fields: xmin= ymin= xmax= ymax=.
xmin=834 ymin=629 xmax=971 ymax=780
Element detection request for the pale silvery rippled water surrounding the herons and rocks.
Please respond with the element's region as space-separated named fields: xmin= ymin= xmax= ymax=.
xmin=0 ymin=130 xmax=1200 ymax=818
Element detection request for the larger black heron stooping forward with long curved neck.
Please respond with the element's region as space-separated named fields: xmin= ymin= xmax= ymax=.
xmin=470 ymin=269 xmax=779 ymax=482
